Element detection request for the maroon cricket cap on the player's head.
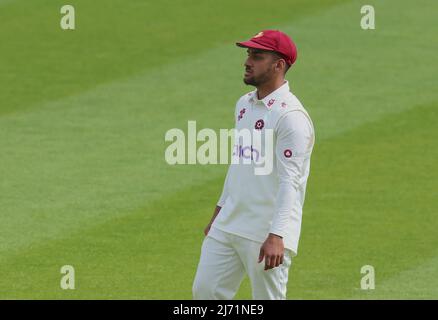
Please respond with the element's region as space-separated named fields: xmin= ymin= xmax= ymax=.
xmin=236 ymin=30 xmax=297 ymax=65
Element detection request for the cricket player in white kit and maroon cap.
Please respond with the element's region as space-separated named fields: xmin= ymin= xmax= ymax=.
xmin=192 ymin=30 xmax=315 ymax=300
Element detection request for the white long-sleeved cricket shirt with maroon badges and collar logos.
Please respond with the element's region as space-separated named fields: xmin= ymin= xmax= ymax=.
xmin=209 ymin=81 xmax=315 ymax=255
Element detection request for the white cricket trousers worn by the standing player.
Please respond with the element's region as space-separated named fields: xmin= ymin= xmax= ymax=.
xmin=192 ymin=228 xmax=292 ymax=300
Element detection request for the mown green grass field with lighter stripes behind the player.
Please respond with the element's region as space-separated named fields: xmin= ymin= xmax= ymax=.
xmin=0 ymin=0 xmax=438 ymax=299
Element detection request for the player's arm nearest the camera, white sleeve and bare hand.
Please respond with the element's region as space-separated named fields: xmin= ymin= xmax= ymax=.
xmin=259 ymin=111 xmax=314 ymax=270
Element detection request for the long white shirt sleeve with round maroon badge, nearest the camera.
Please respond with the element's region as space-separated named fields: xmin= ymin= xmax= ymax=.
xmin=269 ymin=111 xmax=314 ymax=237
